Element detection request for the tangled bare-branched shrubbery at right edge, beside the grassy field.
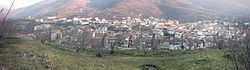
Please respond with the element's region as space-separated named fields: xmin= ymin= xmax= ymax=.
xmin=214 ymin=21 xmax=250 ymax=70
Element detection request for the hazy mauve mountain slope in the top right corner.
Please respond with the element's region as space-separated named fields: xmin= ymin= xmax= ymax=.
xmin=189 ymin=0 xmax=250 ymax=16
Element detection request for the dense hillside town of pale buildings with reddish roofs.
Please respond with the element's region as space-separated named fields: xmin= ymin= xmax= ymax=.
xmin=18 ymin=16 xmax=249 ymax=50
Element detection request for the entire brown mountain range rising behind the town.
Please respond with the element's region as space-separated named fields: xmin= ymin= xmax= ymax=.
xmin=14 ymin=0 xmax=250 ymax=17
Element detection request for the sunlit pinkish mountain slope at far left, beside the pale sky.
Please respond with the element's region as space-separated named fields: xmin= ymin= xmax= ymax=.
xmin=12 ymin=0 xmax=93 ymax=17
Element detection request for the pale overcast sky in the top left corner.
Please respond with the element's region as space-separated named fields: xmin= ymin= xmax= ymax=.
xmin=0 ymin=0 xmax=43 ymax=9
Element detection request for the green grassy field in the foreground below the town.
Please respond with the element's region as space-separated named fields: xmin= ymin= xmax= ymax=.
xmin=0 ymin=37 xmax=230 ymax=70
